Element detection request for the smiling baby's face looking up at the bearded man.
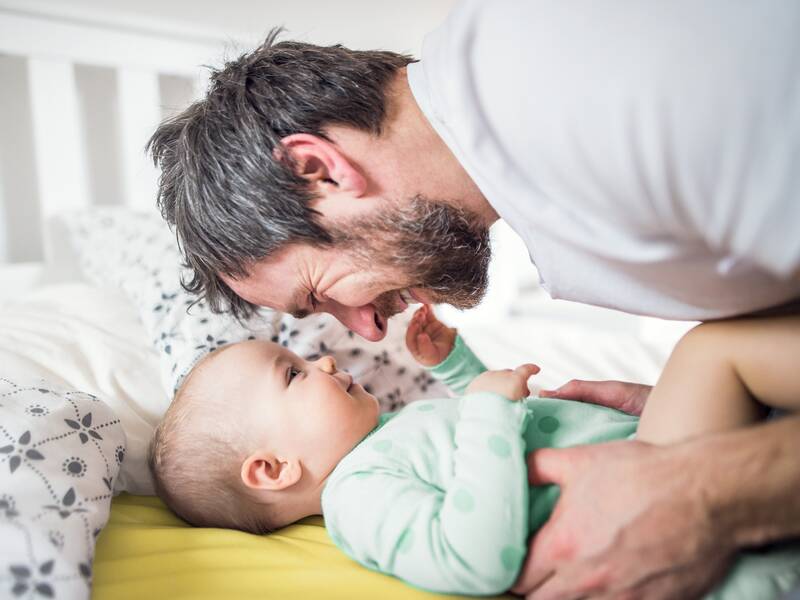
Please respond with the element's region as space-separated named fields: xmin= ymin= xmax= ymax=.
xmin=209 ymin=341 xmax=379 ymax=478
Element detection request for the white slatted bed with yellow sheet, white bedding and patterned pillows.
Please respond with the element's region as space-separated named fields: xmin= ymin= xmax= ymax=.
xmin=0 ymin=6 xmax=692 ymax=600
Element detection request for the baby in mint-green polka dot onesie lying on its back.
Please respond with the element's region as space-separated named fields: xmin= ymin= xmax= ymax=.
xmin=150 ymin=306 xmax=800 ymax=594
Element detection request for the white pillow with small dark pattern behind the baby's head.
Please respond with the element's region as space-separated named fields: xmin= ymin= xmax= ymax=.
xmin=59 ymin=207 xmax=447 ymax=410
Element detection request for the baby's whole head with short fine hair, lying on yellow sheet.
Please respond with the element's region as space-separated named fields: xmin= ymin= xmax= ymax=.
xmin=150 ymin=341 xmax=379 ymax=533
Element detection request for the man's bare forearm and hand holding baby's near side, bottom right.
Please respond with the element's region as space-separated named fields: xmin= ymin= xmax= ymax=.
xmin=515 ymin=416 xmax=800 ymax=600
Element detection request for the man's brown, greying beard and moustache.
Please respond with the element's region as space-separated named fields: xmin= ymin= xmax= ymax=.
xmin=331 ymin=196 xmax=491 ymax=318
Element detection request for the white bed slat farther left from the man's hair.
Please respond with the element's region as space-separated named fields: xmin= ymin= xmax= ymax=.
xmin=28 ymin=58 xmax=89 ymax=218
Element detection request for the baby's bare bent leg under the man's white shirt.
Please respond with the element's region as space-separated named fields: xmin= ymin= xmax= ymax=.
xmin=637 ymin=316 xmax=800 ymax=444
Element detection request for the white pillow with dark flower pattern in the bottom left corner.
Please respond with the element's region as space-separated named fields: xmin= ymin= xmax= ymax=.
xmin=0 ymin=377 xmax=125 ymax=598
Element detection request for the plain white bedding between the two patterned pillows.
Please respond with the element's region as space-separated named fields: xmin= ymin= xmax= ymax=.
xmin=0 ymin=283 xmax=163 ymax=494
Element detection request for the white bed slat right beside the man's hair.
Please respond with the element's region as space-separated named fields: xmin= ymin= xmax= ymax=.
xmin=117 ymin=69 xmax=161 ymax=209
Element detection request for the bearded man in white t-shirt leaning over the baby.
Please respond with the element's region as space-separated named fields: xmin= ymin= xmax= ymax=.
xmin=151 ymin=0 xmax=800 ymax=598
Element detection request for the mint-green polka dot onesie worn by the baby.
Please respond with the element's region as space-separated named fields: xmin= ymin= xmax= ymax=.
xmin=322 ymin=337 xmax=637 ymax=594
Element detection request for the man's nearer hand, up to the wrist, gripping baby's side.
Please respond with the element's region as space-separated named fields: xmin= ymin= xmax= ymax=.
xmin=513 ymin=441 xmax=735 ymax=600
